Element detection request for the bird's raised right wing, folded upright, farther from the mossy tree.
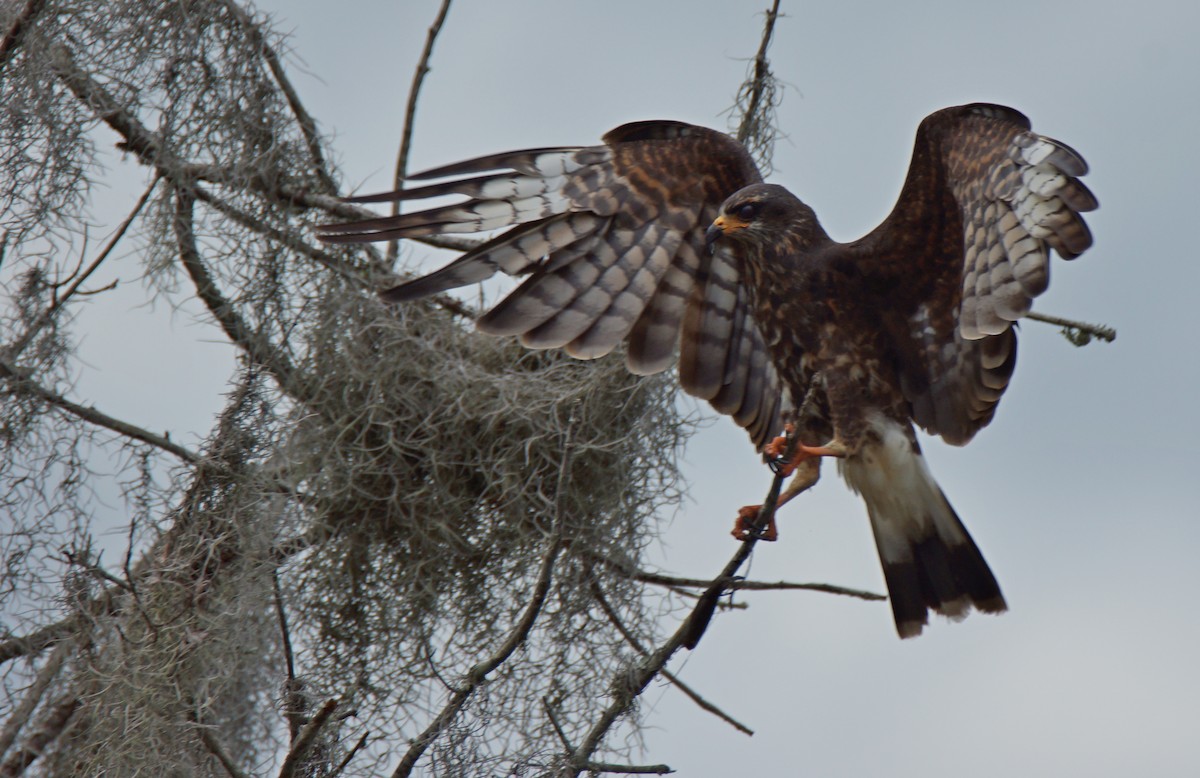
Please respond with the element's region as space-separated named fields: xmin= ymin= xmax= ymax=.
xmin=856 ymin=103 xmax=1097 ymax=444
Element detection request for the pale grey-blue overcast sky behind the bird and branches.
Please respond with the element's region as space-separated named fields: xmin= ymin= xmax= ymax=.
xmin=78 ymin=0 xmax=1200 ymax=778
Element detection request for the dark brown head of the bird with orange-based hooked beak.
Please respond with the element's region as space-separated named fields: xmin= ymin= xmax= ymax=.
xmin=704 ymin=184 xmax=824 ymax=249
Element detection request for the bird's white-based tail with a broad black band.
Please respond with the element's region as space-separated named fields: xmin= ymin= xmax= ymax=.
xmin=841 ymin=421 xmax=1008 ymax=638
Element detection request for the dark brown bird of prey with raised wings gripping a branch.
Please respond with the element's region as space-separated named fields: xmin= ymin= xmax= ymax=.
xmin=320 ymin=103 xmax=1097 ymax=638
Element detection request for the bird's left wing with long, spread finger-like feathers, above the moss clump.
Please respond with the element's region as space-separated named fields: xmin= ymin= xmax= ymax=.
xmin=319 ymin=121 xmax=782 ymax=445
